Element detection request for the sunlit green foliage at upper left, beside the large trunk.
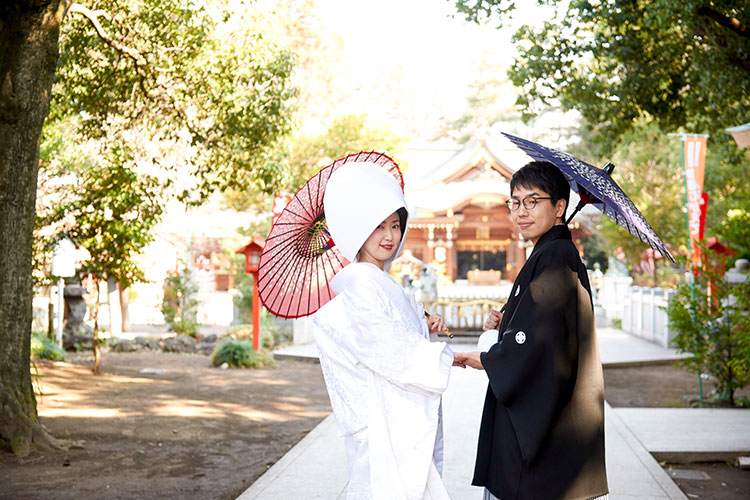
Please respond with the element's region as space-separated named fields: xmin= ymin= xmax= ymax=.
xmin=50 ymin=0 xmax=295 ymax=204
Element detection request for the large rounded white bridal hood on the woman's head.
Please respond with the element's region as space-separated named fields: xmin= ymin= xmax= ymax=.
xmin=323 ymin=162 xmax=409 ymax=270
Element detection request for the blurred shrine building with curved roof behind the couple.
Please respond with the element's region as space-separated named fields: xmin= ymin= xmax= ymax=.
xmin=404 ymin=137 xmax=583 ymax=285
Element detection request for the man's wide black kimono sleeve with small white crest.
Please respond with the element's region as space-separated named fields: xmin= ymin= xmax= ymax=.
xmin=481 ymin=252 xmax=578 ymax=460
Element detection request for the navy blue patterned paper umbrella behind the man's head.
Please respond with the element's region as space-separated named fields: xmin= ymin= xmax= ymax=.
xmin=503 ymin=132 xmax=675 ymax=262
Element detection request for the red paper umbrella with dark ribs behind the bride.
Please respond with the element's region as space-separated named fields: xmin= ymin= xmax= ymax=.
xmin=258 ymin=152 xmax=404 ymax=318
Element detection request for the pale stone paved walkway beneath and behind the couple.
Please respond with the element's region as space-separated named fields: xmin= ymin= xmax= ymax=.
xmin=238 ymin=328 xmax=750 ymax=500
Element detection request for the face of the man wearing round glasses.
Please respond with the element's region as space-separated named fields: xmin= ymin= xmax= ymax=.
xmin=510 ymin=186 xmax=565 ymax=245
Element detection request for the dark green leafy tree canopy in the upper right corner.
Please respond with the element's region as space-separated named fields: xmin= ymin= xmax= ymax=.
xmin=456 ymin=0 xmax=750 ymax=146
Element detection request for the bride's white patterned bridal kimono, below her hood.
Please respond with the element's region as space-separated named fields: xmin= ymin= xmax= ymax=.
xmin=313 ymin=262 xmax=453 ymax=500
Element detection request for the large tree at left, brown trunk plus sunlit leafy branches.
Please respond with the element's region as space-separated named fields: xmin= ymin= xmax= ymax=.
xmin=0 ymin=0 xmax=294 ymax=455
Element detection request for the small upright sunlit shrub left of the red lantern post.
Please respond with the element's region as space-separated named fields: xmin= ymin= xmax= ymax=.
xmin=161 ymin=267 xmax=198 ymax=336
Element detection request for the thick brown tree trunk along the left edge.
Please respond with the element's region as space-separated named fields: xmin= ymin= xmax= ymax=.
xmin=0 ymin=0 xmax=64 ymax=456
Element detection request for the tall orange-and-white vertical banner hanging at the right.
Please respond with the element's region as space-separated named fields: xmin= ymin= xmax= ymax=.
xmin=682 ymin=136 xmax=706 ymax=268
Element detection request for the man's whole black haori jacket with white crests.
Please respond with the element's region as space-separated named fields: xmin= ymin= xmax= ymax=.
xmin=472 ymin=225 xmax=608 ymax=500
